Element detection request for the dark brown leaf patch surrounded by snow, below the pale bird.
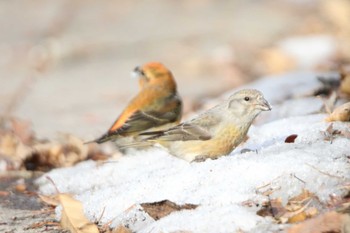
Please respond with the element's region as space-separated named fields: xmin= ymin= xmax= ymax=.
xmin=141 ymin=200 xmax=198 ymax=220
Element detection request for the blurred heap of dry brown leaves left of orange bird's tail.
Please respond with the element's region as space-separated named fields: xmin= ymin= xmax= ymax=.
xmin=0 ymin=115 xmax=109 ymax=171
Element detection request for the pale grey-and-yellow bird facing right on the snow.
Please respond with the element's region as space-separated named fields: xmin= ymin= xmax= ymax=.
xmin=125 ymin=89 xmax=271 ymax=162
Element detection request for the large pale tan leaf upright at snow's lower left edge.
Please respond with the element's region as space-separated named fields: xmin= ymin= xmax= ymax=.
xmin=58 ymin=193 xmax=99 ymax=233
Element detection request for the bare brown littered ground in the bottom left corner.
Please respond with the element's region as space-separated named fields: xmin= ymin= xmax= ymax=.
xmin=0 ymin=171 xmax=67 ymax=233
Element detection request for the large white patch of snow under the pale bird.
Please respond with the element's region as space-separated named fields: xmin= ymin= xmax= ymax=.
xmin=37 ymin=72 xmax=350 ymax=232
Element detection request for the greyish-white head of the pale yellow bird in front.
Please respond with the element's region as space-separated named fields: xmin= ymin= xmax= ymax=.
xmin=228 ymin=89 xmax=271 ymax=119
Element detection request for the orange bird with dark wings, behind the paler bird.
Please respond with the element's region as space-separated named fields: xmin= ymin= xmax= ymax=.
xmin=87 ymin=62 xmax=182 ymax=144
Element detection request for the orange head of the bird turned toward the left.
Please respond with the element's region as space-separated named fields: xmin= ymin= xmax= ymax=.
xmin=134 ymin=62 xmax=176 ymax=90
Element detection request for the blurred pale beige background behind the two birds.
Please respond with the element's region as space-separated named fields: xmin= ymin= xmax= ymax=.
xmin=0 ymin=0 xmax=350 ymax=139
